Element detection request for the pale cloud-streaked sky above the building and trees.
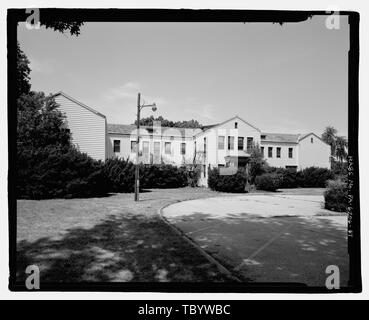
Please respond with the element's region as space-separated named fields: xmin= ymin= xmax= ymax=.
xmin=18 ymin=16 xmax=349 ymax=136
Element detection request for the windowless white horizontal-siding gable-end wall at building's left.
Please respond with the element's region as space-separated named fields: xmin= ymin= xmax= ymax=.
xmin=55 ymin=94 xmax=107 ymax=160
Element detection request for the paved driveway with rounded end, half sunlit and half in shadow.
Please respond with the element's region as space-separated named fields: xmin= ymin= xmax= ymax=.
xmin=162 ymin=193 xmax=349 ymax=287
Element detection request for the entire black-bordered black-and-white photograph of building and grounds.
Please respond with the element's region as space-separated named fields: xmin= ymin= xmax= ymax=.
xmin=4 ymin=8 xmax=362 ymax=293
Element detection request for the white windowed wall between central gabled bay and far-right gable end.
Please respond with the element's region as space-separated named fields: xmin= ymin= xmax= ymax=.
xmin=260 ymin=141 xmax=299 ymax=168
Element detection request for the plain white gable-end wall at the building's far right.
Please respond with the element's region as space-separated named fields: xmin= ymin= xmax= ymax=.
xmin=299 ymin=134 xmax=331 ymax=170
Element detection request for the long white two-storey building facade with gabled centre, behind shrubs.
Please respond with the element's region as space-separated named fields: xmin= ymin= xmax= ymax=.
xmin=55 ymin=92 xmax=330 ymax=186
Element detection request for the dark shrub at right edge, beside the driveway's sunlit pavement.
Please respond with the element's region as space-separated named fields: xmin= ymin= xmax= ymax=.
xmin=324 ymin=180 xmax=348 ymax=212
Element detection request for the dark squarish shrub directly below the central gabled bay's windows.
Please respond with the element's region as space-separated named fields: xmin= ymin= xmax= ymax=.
xmin=208 ymin=168 xmax=247 ymax=193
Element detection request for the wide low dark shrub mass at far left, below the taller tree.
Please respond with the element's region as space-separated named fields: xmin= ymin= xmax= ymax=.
xmin=17 ymin=145 xmax=108 ymax=199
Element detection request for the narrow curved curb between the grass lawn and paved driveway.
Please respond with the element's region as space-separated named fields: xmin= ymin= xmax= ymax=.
xmin=157 ymin=199 xmax=242 ymax=282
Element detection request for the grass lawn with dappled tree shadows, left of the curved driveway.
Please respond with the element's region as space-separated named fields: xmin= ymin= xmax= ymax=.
xmin=17 ymin=188 xmax=234 ymax=285
